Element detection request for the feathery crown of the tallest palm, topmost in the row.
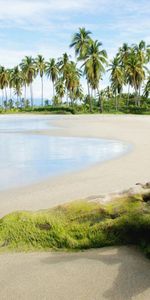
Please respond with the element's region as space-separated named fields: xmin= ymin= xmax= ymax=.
xmin=70 ymin=27 xmax=91 ymax=60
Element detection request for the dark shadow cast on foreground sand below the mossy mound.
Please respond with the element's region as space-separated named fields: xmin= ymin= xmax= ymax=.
xmin=42 ymin=247 xmax=150 ymax=300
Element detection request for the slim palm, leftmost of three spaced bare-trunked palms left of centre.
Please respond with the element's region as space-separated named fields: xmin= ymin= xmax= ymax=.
xmin=20 ymin=56 xmax=37 ymax=106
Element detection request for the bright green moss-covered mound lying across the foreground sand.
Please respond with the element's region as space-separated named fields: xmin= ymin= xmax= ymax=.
xmin=0 ymin=193 xmax=150 ymax=258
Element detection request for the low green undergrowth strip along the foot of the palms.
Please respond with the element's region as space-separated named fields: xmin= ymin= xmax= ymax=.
xmin=0 ymin=99 xmax=150 ymax=115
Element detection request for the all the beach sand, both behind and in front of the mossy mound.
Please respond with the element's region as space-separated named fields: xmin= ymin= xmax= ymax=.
xmin=0 ymin=115 xmax=150 ymax=300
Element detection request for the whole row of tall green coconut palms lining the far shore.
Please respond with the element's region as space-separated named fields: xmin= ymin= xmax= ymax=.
xmin=0 ymin=28 xmax=150 ymax=114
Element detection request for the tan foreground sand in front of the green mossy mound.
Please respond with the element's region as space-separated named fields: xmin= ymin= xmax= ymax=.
xmin=0 ymin=247 xmax=150 ymax=300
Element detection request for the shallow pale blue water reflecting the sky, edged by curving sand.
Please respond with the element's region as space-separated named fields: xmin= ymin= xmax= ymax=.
xmin=0 ymin=116 xmax=129 ymax=190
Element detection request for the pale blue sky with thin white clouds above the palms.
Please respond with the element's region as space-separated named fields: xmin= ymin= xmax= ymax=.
xmin=0 ymin=0 xmax=150 ymax=98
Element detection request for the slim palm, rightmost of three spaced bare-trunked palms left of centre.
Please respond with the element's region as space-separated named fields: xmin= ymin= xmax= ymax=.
xmin=45 ymin=58 xmax=59 ymax=98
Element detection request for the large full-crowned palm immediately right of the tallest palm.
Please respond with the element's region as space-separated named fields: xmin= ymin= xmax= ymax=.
xmin=82 ymin=40 xmax=107 ymax=111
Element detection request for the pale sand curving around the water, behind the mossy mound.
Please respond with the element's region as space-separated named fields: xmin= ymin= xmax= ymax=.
xmin=0 ymin=115 xmax=150 ymax=216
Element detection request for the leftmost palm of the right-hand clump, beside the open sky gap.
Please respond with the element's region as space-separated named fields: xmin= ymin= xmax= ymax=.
xmin=108 ymin=56 xmax=124 ymax=110
